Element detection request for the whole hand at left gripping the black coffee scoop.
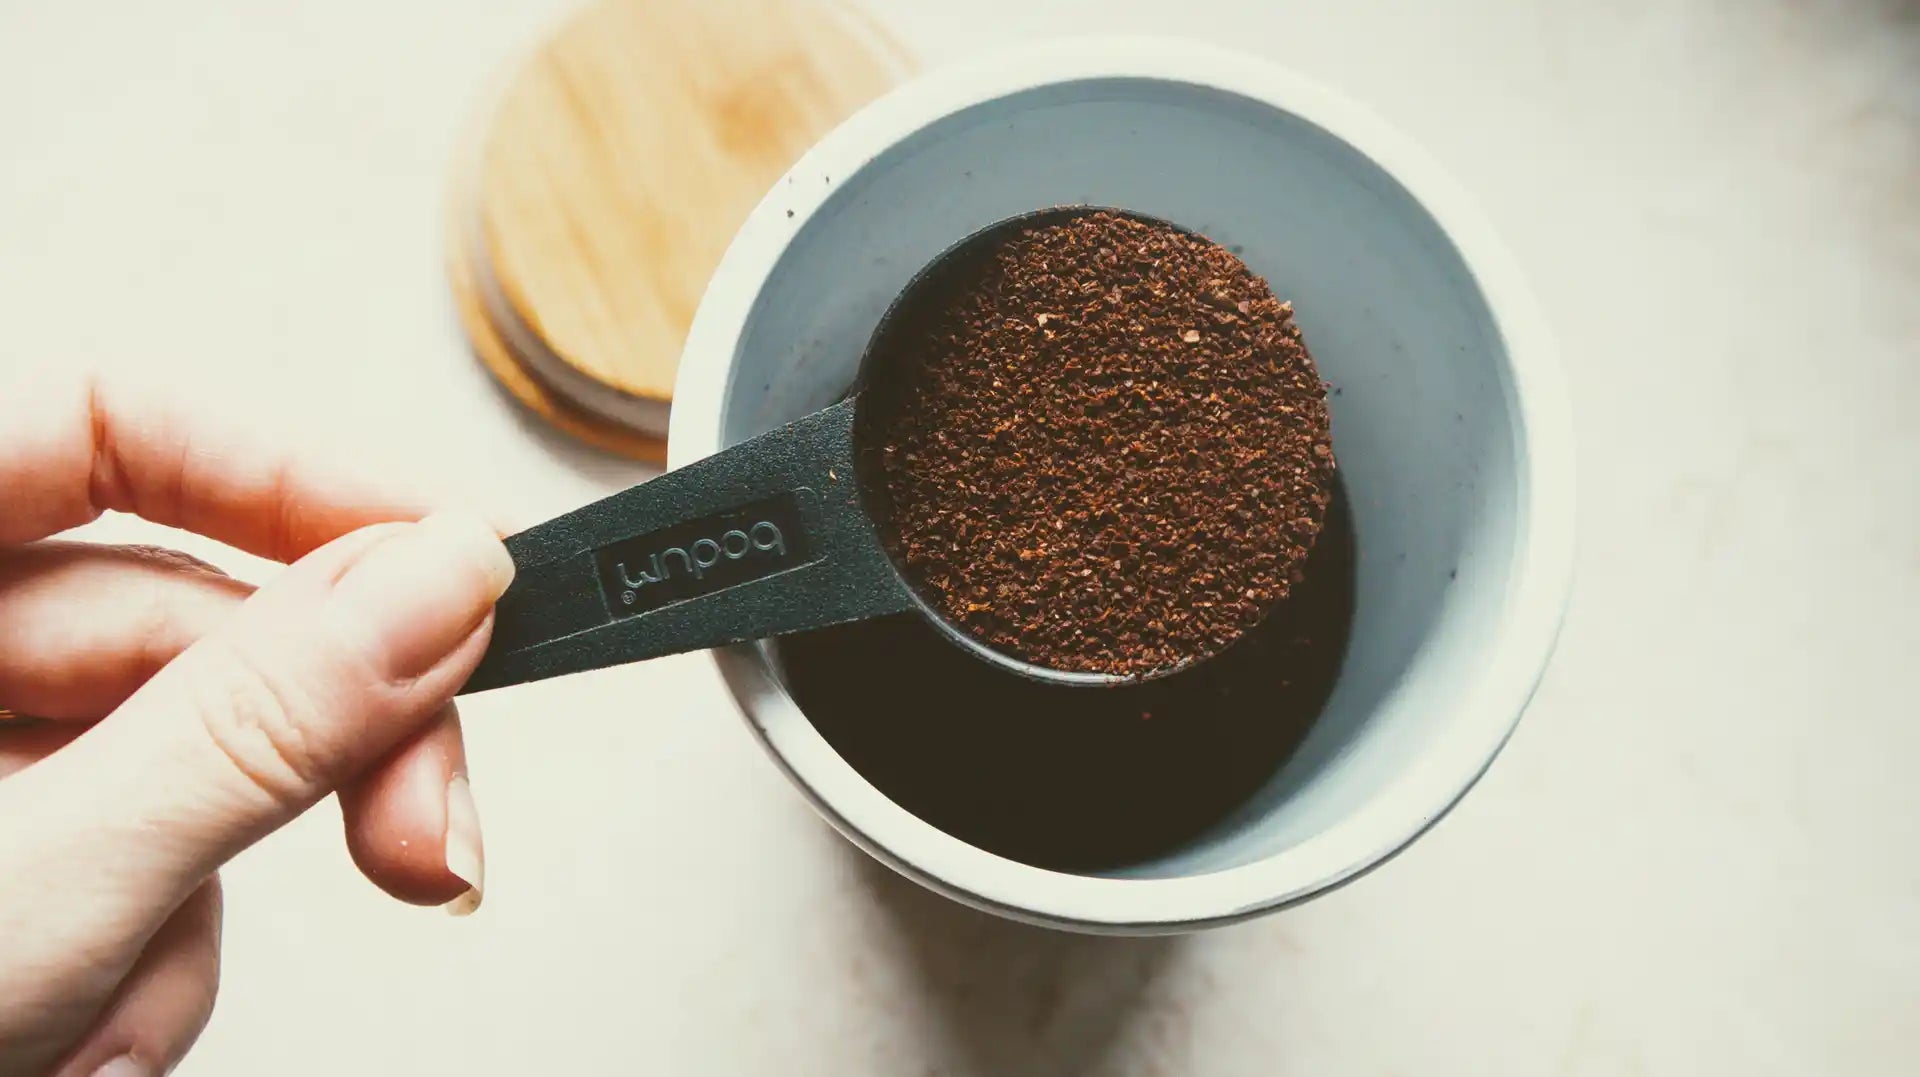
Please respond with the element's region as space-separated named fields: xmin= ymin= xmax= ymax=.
xmin=0 ymin=372 xmax=513 ymax=1077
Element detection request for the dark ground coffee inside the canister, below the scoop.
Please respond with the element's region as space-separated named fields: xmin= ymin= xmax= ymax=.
xmin=774 ymin=484 xmax=1354 ymax=872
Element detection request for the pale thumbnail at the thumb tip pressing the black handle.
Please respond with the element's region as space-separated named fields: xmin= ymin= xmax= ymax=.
xmin=332 ymin=513 xmax=513 ymax=678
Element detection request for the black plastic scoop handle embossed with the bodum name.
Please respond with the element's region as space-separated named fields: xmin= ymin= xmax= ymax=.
xmin=461 ymin=399 xmax=912 ymax=693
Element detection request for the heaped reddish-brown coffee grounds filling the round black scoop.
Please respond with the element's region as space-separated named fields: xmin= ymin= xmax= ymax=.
xmin=860 ymin=213 xmax=1334 ymax=676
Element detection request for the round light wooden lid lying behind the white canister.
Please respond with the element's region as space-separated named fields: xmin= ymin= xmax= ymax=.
xmin=449 ymin=0 xmax=910 ymax=461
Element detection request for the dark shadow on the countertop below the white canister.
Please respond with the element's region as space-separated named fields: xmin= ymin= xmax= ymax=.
xmin=841 ymin=843 xmax=1187 ymax=1077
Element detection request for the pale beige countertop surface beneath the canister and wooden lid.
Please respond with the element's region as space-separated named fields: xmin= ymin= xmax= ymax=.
xmin=0 ymin=0 xmax=1920 ymax=1077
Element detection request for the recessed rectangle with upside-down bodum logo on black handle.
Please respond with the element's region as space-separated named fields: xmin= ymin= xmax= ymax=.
xmin=595 ymin=491 xmax=814 ymax=616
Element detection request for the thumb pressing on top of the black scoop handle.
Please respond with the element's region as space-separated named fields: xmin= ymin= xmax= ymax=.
xmin=10 ymin=515 xmax=513 ymax=912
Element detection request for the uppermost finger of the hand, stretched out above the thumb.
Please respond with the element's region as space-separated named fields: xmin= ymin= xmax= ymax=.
xmin=0 ymin=366 xmax=428 ymax=561
